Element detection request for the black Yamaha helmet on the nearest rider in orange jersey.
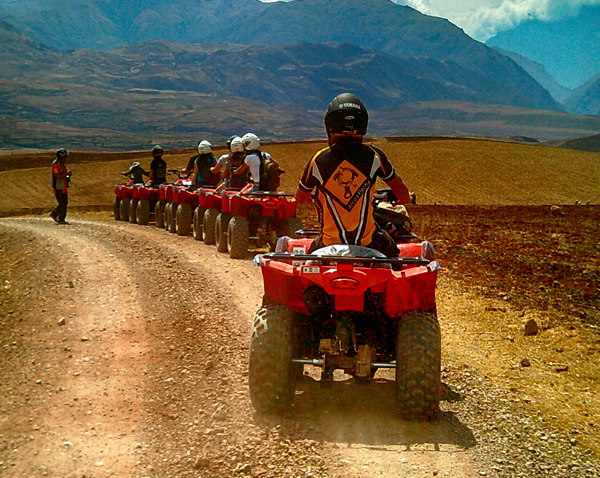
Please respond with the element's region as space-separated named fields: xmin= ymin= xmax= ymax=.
xmin=325 ymin=93 xmax=369 ymax=136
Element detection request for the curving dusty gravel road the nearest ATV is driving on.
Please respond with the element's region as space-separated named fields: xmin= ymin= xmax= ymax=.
xmin=0 ymin=218 xmax=599 ymax=478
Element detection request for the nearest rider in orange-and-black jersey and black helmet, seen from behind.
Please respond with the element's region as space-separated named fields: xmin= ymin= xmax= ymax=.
xmin=296 ymin=93 xmax=410 ymax=257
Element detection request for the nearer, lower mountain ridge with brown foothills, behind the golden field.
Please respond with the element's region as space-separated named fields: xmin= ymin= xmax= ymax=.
xmin=0 ymin=18 xmax=600 ymax=150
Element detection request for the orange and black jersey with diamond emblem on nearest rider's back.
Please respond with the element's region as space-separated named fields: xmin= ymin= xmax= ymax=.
xmin=299 ymin=142 xmax=395 ymax=246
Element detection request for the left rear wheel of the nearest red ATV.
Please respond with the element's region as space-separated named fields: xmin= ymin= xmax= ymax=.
xmin=249 ymin=305 xmax=297 ymax=413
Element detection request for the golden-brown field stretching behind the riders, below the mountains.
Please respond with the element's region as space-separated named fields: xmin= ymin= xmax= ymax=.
xmin=0 ymin=138 xmax=600 ymax=215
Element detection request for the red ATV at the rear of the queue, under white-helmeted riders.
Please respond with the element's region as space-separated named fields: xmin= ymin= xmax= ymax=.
xmin=215 ymin=191 xmax=302 ymax=259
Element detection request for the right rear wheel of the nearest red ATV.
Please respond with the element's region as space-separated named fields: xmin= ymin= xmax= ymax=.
xmin=396 ymin=311 xmax=442 ymax=420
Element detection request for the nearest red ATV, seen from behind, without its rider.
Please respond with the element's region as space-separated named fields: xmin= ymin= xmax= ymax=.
xmin=249 ymin=190 xmax=441 ymax=419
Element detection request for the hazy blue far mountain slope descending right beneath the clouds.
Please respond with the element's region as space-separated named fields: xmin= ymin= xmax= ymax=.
xmin=208 ymin=0 xmax=562 ymax=110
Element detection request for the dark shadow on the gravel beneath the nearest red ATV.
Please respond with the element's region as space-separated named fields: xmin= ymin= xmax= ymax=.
xmin=257 ymin=376 xmax=477 ymax=451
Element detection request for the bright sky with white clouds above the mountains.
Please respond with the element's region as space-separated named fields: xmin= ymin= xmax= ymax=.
xmin=261 ymin=0 xmax=600 ymax=41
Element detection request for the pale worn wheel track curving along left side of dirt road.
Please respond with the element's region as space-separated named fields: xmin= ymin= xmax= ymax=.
xmin=0 ymin=219 xmax=147 ymax=476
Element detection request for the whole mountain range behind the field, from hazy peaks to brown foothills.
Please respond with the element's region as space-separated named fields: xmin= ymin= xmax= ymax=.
xmin=0 ymin=0 xmax=598 ymax=147
